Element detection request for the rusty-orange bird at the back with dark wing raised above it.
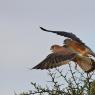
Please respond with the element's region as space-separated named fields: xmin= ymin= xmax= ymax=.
xmin=40 ymin=27 xmax=95 ymax=57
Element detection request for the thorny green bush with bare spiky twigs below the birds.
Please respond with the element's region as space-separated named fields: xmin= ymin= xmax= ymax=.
xmin=19 ymin=64 xmax=95 ymax=95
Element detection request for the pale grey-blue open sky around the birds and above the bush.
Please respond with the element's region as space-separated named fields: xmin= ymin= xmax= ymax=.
xmin=0 ymin=0 xmax=95 ymax=95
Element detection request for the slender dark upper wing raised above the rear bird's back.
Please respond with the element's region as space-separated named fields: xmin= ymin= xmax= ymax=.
xmin=40 ymin=27 xmax=85 ymax=45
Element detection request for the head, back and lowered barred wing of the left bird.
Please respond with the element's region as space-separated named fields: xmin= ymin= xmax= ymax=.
xmin=33 ymin=45 xmax=76 ymax=69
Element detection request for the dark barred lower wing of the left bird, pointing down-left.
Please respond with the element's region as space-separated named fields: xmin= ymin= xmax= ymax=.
xmin=32 ymin=53 xmax=75 ymax=69
